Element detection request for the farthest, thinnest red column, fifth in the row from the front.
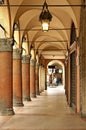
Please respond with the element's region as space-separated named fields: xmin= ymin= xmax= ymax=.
xmin=35 ymin=63 xmax=40 ymax=95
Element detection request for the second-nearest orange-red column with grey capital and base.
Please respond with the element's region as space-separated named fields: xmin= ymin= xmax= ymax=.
xmin=13 ymin=48 xmax=23 ymax=106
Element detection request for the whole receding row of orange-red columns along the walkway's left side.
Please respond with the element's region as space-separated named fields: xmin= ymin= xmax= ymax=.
xmin=0 ymin=38 xmax=45 ymax=115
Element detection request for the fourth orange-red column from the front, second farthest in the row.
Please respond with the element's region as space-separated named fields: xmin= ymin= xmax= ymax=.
xmin=30 ymin=59 xmax=36 ymax=97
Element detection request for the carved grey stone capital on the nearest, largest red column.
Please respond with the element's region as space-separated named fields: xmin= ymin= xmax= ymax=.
xmin=0 ymin=38 xmax=13 ymax=52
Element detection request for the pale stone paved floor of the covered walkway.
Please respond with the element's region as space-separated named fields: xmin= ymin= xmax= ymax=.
xmin=0 ymin=86 xmax=86 ymax=130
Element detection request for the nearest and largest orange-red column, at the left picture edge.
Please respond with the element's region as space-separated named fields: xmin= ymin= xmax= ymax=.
xmin=0 ymin=39 xmax=14 ymax=115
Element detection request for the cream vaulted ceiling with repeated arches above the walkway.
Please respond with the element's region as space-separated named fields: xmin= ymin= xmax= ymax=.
xmin=1 ymin=0 xmax=81 ymax=59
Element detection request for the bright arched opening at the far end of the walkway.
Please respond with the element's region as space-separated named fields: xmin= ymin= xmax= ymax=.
xmin=47 ymin=60 xmax=65 ymax=86
